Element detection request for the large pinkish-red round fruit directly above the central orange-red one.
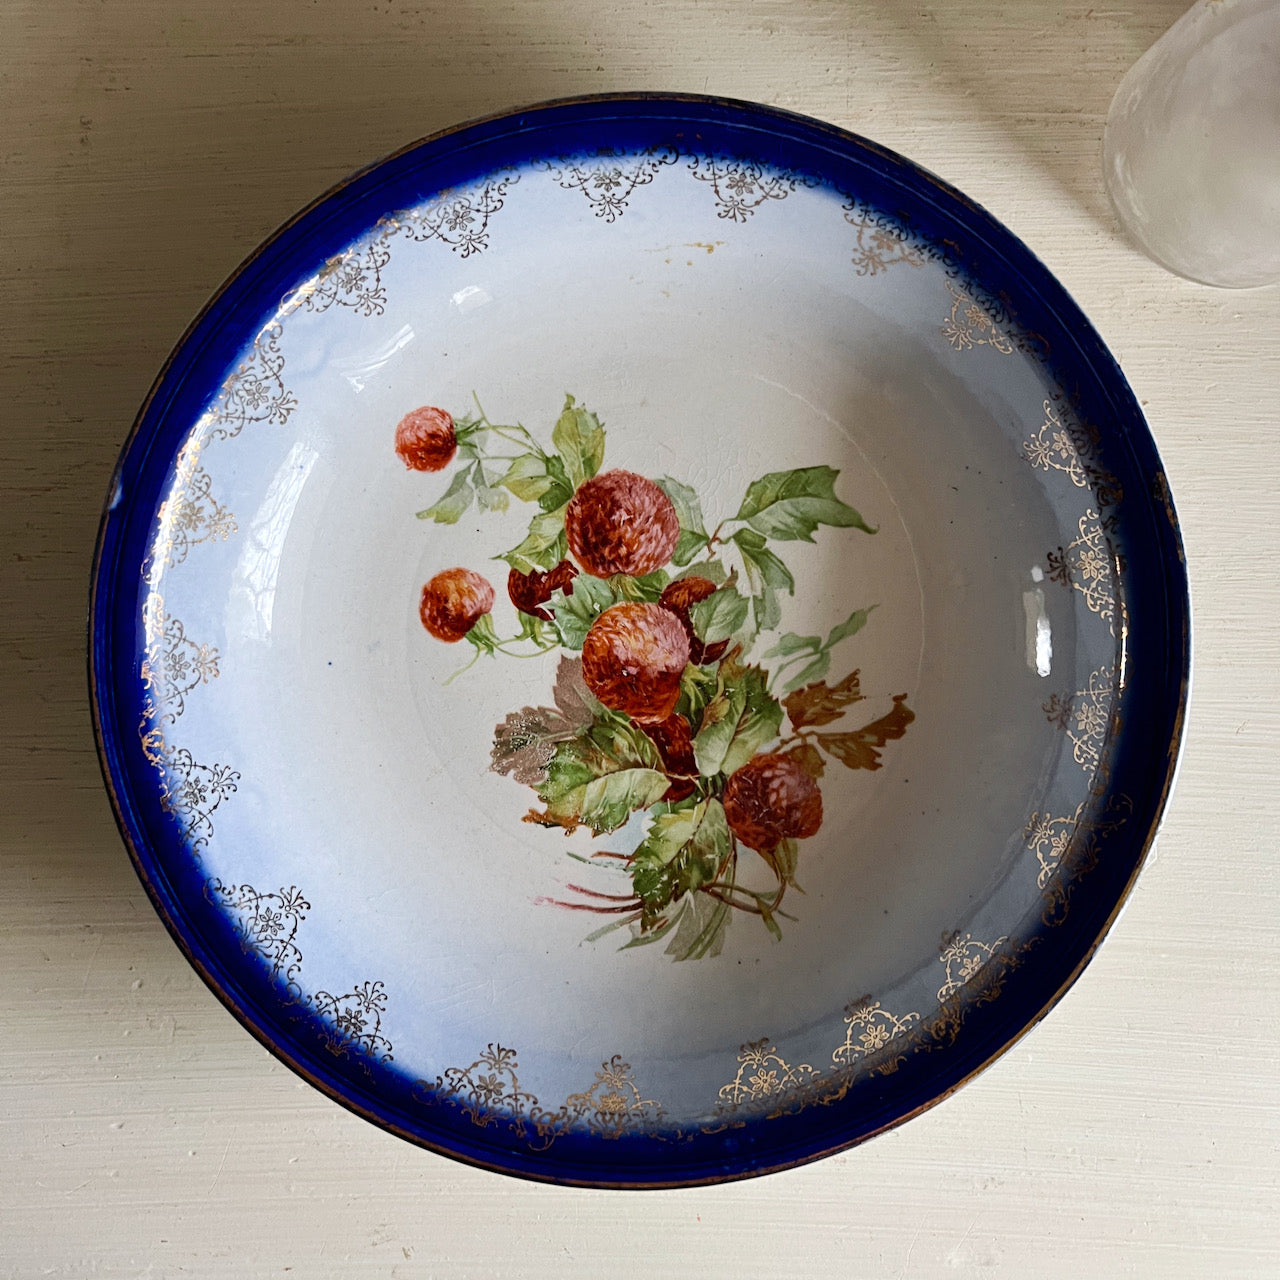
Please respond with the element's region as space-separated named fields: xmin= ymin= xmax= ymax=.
xmin=564 ymin=471 xmax=680 ymax=577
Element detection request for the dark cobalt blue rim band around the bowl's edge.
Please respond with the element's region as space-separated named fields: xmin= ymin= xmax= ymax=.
xmin=90 ymin=93 xmax=1190 ymax=1187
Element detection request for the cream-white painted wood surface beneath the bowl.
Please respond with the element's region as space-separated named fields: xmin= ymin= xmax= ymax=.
xmin=0 ymin=0 xmax=1280 ymax=1280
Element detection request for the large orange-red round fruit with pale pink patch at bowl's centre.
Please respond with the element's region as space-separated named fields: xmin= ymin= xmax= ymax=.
xmin=582 ymin=604 xmax=689 ymax=724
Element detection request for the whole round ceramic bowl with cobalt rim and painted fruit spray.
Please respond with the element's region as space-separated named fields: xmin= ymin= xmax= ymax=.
xmin=91 ymin=95 xmax=1189 ymax=1187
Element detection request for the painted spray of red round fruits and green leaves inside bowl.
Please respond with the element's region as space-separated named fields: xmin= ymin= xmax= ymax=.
xmin=396 ymin=396 xmax=915 ymax=960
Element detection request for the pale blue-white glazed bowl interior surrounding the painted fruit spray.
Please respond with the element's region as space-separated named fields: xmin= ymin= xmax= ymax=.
xmin=145 ymin=154 xmax=1116 ymax=1123
